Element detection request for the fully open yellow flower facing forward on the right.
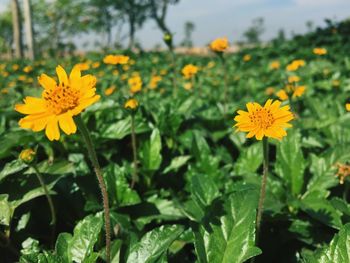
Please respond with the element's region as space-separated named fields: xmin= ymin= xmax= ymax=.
xmin=234 ymin=99 xmax=294 ymax=140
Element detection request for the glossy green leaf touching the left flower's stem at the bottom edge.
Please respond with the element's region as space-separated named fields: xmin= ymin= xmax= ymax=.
xmin=69 ymin=215 xmax=103 ymax=263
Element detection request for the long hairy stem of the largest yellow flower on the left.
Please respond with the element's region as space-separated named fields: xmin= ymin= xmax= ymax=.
xmin=76 ymin=115 xmax=111 ymax=263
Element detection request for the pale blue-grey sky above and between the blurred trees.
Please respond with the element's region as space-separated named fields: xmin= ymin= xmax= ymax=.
xmin=0 ymin=0 xmax=350 ymax=48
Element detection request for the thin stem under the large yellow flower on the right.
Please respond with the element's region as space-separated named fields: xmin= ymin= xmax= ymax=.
xmin=256 ymin=137 xmax=269 ymax=243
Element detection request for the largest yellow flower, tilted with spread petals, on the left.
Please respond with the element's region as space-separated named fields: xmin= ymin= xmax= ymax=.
xmin=15 ymin=66 xmax=100 ymax=141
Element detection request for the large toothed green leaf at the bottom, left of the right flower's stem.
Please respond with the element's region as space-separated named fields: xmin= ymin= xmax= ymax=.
xmin=194 ymin=190 xmax=261 ymax=263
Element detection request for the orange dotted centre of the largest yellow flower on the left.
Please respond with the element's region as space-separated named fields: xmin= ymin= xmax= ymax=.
xmin=43 ymin=83 xmax=79 ymax=115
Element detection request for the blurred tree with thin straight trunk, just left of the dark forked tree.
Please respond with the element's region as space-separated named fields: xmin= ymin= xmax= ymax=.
xmin=114 ymin=0 xmax=149 ymax=49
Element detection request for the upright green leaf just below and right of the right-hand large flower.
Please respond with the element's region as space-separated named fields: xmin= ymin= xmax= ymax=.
xmin=275 ymin=131 xmax=305 ymax=195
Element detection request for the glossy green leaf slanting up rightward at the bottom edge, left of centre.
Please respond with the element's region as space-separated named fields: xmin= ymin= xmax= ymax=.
xmin=126 ymin=225 xmax=184 ymax=263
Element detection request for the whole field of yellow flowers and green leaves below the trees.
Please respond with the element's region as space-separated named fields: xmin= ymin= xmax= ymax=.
xmin=0 ymin=20 xmax=350 ymax=263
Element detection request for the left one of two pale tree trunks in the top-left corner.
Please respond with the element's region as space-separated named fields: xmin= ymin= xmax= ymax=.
xmin=11 ymin=0 xmax=23 ymax=58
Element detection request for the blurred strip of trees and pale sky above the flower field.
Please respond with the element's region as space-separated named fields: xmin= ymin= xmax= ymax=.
xmin=0 ymin=0 xmax=350 ymax=58
